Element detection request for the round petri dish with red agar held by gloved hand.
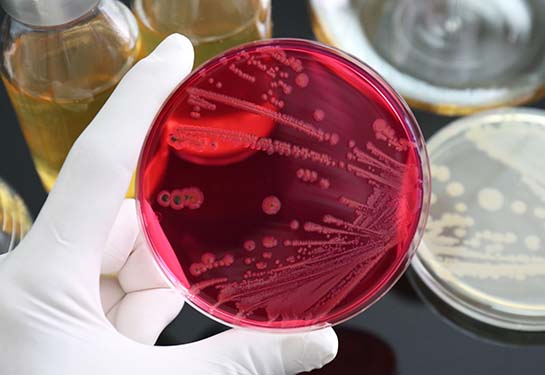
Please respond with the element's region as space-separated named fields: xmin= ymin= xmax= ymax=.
xmin=137 ymin=39 xmax=430 ymax=330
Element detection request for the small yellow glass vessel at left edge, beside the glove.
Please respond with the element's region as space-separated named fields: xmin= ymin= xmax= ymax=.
xmin=0 ymin=178 xmax=32 ymax=255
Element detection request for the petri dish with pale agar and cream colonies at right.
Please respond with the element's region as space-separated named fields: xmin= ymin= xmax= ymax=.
xmin=413 ymin=108 xmax=545 ymax=331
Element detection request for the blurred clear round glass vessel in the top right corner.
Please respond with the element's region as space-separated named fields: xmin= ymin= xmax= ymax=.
xmin=309 ymin=0 xmax=545 ymax=115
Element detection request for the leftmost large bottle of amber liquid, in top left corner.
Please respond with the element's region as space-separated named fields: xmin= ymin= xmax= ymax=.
xmin=0 ymin=0 xmax=141 ymax=191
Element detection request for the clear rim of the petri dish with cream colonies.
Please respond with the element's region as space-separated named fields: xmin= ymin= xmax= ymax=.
xmin=411 ymin=107 xmax=545 ymax=332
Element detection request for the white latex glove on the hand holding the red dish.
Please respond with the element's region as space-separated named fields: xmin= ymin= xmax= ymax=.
xmin=0 ymin=35 xmax=337 ymax=375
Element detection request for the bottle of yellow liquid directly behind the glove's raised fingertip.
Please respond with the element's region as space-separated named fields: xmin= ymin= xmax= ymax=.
xmin=133 ymin=0 xmax=272 ymax=67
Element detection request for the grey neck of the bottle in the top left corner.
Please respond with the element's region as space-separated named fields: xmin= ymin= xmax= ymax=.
xmin=0 ymin=0 xmax=101 ymax=27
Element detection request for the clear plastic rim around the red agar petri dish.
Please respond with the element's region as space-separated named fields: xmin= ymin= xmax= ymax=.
xmin=135 ymin=38 xmax=431 ymax=332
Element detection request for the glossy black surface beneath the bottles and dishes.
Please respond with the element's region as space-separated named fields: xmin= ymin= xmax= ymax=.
xmin=0 ymin=0 xmax=545 ymax=375
